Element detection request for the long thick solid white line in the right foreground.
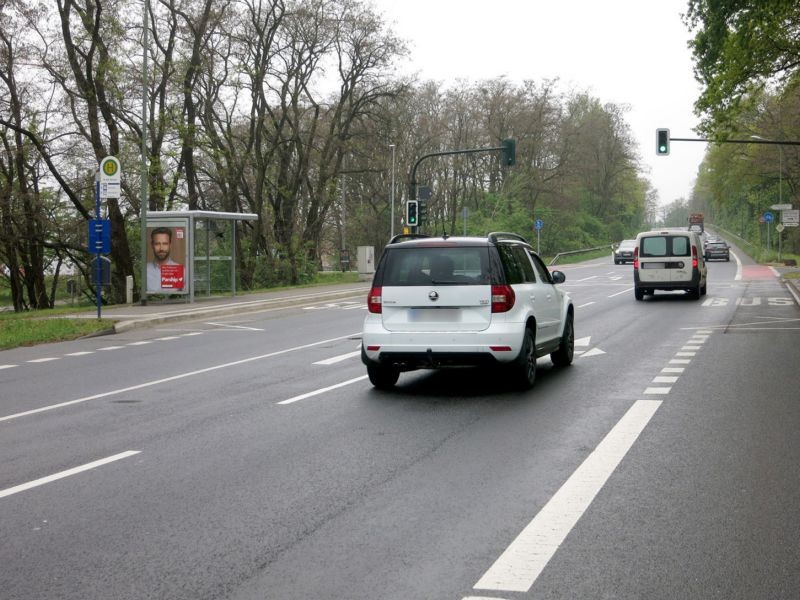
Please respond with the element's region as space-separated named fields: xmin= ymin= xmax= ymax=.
xmin=474 ymin=400 xmax=662 ymax=592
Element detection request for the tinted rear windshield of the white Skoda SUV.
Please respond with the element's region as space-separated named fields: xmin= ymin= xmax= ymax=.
xmin=382 ymin=246 xmax=490 ymax=286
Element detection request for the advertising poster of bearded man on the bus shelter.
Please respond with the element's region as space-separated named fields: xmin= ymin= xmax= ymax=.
xmin=147 ymin=221 xmax=189 ymax=294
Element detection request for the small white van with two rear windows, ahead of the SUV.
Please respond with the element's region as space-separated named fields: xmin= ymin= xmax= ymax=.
xmin=633 ymin=230 xmax=708 ymax=300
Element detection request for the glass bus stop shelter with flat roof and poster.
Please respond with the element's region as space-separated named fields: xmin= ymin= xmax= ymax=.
xmin=142 ymin=210 xmax=258 ymax=302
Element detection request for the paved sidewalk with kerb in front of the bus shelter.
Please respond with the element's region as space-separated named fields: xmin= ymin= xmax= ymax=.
xmin=71 ymin=282 xmax=369 ymax=333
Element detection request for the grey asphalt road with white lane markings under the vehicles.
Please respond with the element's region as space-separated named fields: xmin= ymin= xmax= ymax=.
xmin=0 ymin=245 xmax=800 ymax=600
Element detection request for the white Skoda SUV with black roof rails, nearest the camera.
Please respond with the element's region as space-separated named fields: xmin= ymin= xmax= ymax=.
xmin=361 ymin=233 xmax=575 ymax=388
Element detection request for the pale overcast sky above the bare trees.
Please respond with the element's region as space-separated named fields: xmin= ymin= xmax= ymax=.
xmin=371 ymin=0 xmax=706 ymax=205
